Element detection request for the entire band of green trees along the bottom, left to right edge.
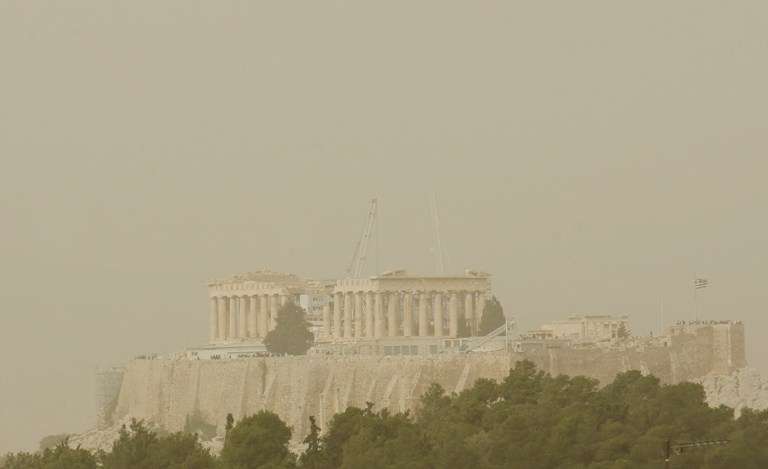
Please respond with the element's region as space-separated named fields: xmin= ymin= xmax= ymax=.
xmin=6 ymin=361 xmax=768 ymax=469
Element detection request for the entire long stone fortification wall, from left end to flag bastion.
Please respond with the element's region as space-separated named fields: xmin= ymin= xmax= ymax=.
xmin=113 ymin=327 xmax=743 ymax=439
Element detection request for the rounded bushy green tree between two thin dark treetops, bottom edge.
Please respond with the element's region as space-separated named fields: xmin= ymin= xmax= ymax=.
xmin=221 ymin=410 xmax=295 ymax=469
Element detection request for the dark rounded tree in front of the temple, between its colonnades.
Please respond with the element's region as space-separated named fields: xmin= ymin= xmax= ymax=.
xmin=264 ymin=301 xmax=314 ymax=355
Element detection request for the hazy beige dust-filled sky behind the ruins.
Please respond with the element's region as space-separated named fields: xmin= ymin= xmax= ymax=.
xmin=0 ymin=0 xmax=768 ymax=452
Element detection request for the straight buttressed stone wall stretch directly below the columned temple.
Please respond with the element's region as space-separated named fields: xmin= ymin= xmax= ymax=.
xmin=115 ymin=355 xmax=512 ymax=437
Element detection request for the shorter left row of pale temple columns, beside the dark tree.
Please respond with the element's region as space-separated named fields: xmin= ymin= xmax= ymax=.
xmin=208 ymin=294 xmax=288 ymax=342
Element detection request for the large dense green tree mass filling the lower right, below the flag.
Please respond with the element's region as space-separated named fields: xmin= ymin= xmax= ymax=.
xmin=304 ymin=361 xmax=768 ymax=469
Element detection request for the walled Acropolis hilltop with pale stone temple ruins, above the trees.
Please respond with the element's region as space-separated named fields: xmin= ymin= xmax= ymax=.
xmin=84 ymin=271 xmax=746 ymax=450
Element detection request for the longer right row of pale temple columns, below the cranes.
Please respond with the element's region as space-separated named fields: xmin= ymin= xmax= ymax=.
xmin=323 ymin=290 xmax=485 ymax=339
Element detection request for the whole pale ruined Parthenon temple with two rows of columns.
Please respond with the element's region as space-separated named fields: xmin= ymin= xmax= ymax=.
xmin=208 ymin=271 xmax=491 ymax=344
